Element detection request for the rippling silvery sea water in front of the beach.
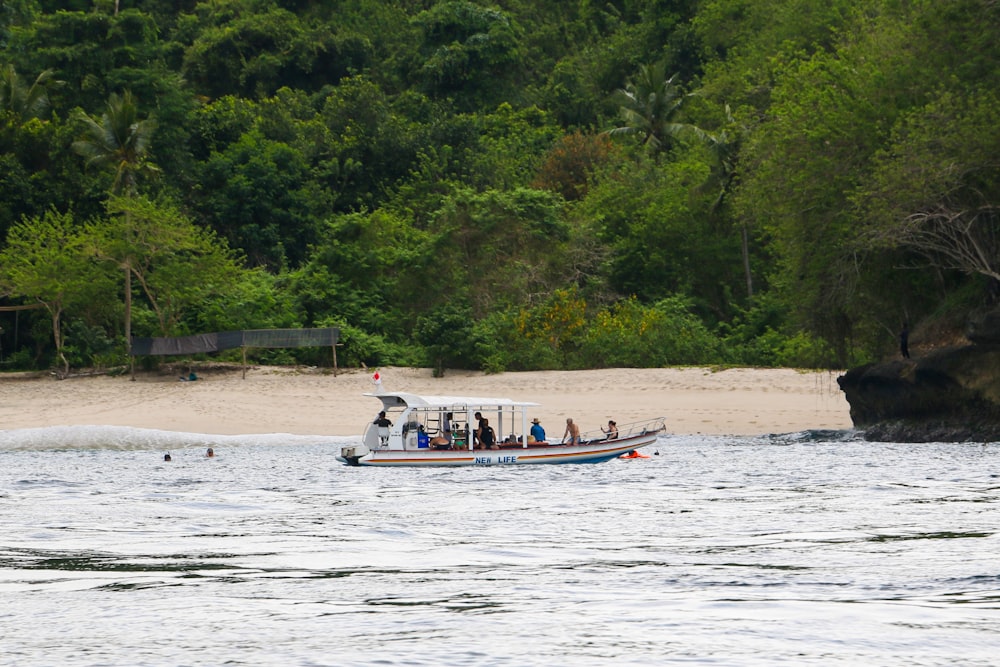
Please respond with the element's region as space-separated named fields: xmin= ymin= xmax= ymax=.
xmin=0 ymin=427 xmax=1000 ymax=666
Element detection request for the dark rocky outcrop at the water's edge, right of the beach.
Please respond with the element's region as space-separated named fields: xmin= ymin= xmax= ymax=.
xmin=837 ymin=344 xmax=1000 ymax=442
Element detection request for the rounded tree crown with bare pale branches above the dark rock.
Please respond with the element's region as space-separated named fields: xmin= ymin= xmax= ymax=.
xmin=855 ymin=90 xmax=1000 ymax=280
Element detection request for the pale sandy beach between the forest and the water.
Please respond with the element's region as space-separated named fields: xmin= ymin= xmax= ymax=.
xmin=0 ymin=366 xmax=852 ymax=439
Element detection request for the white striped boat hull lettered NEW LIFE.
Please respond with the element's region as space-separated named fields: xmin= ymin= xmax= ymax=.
xmin=337 ymin=430 xmax=662 ymax=467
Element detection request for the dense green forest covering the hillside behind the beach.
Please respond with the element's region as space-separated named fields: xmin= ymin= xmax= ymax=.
xmin=0 ymin=0 xmax=1000 ymax=371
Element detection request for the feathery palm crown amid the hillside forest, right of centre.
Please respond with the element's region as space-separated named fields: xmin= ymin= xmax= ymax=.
xmin=608 ymin=61 xmax=702 ymax=155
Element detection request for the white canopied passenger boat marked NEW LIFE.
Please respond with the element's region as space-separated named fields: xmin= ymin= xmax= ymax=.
xmin=337 ymin=392 xmax=666 ymax=467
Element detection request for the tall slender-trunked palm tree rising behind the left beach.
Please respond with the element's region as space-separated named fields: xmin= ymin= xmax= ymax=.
xmin=73 ymin=90 xmax=157 ymax=380
